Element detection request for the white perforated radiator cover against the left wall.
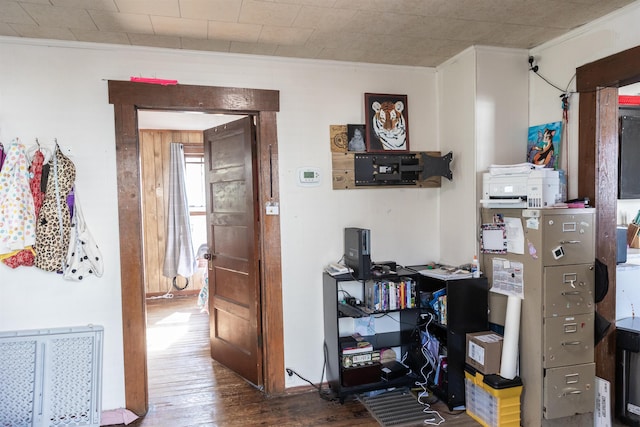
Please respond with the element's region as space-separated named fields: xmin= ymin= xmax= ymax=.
xmin=0 ymin=325 xmax=104 ymax=427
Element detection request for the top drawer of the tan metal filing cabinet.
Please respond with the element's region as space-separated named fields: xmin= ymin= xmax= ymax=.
xmin=540 ymin=213 xmax=596 ymax=266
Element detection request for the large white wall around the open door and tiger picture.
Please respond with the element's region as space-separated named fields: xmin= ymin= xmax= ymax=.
xmin=0 ymin=37 xmax=440 ymax=409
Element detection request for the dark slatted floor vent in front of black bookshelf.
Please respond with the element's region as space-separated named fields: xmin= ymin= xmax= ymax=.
xmin=359 ymin=389 xmax=433 ymax=427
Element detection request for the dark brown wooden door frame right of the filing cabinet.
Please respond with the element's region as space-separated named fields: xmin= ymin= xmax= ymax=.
xmin=576 ymin=46 xmax=640 ymax=408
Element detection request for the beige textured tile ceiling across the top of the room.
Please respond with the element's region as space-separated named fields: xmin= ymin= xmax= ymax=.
xmin=0 ymin=0 xmax=633 ymax=67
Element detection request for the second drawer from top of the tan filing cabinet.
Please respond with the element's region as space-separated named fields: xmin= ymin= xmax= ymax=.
xmin=542 ymin=263 xmax=595 ymax=317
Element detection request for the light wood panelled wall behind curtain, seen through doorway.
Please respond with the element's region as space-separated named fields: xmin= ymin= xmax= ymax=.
xmin=140 ymin=130 xmax=204 ymax=295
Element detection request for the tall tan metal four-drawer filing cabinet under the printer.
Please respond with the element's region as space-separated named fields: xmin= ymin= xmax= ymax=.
xmin=482 ymin=208 xmax=596 ymax=427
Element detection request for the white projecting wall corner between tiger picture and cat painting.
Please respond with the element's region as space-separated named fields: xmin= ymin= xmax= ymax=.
xmin=437 ymin=46 xmax=528 ymax=265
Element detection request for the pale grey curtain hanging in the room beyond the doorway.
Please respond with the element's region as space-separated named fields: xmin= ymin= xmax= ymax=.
xmin=162 ymin=142 xmax=197 ymax=278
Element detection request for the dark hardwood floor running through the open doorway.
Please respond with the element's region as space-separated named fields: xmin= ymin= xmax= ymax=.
xmin=114 ymin=296 xmax=478 ymax=427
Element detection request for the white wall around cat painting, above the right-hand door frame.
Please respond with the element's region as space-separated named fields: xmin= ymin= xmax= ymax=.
xmin=529 ymin=2 xmax=640 ymax=198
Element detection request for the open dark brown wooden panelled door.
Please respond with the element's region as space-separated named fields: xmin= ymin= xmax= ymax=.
xmin=204 ymin=117 xmax=263 ymax=388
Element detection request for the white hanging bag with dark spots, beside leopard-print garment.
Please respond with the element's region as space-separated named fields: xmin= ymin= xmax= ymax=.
xmin=63 ymin=192 xmax=104 ymax=281
